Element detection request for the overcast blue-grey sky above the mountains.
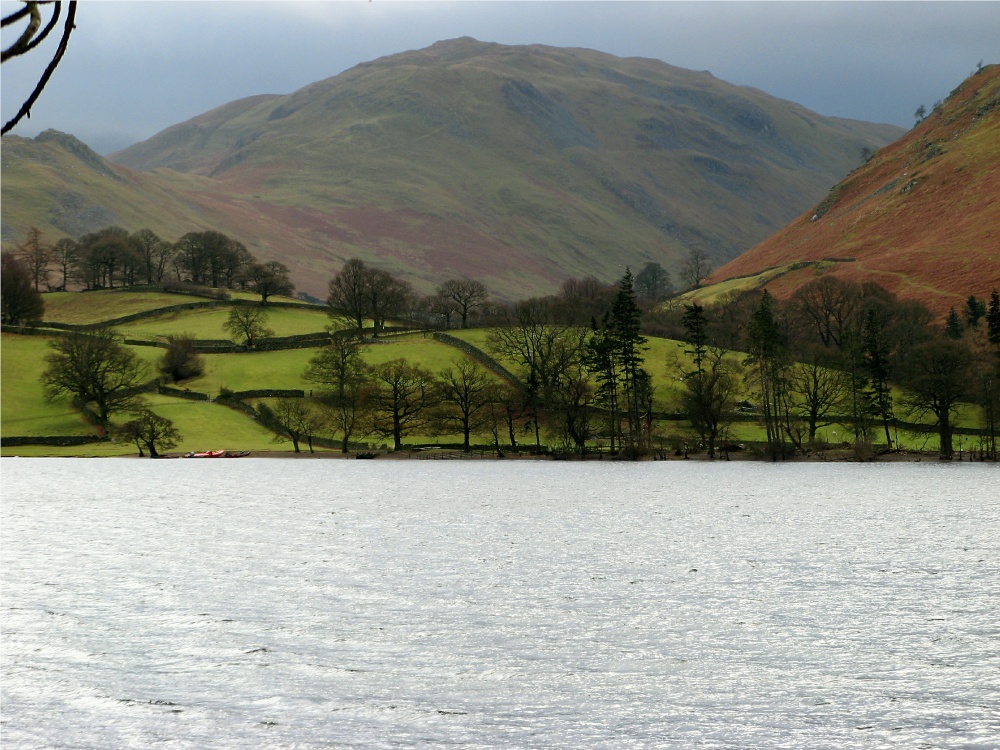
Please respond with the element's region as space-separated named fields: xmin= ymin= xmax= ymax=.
xmin=0 ymin=0 xmax=1000 ymax=154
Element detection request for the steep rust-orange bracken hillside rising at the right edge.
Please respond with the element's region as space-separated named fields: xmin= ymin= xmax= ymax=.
xmin=709 ymin=65 xmax=1000 ymax=315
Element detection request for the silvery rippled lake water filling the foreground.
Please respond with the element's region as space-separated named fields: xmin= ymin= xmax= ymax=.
xmin=0 ymin=459 xmax=1000 ymax=750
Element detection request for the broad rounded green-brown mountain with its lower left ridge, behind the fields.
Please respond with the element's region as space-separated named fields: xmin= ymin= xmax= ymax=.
xmin=3 ymin=38 xmax=902 ymax=297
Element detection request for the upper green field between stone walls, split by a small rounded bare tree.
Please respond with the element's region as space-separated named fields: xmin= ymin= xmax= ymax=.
xmin=117 ymin=306 xmax=330 ymax=339
